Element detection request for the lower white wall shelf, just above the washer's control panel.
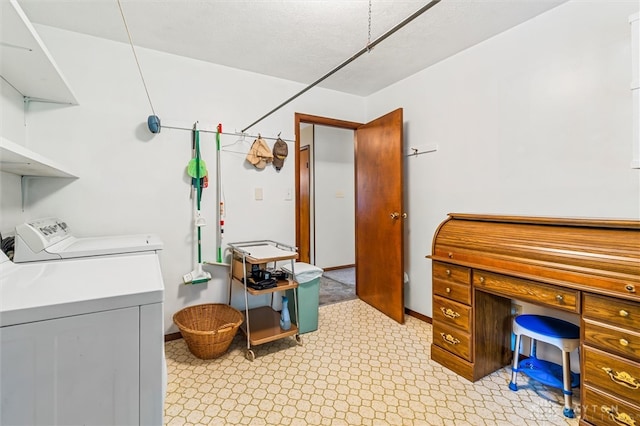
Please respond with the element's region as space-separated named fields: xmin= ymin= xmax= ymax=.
xmin=0 ymin=137 xmax=78 ymax=178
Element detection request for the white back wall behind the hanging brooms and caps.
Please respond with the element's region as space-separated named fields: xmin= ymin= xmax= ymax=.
xmin=1 ymin=26 xmax=365 ymax=332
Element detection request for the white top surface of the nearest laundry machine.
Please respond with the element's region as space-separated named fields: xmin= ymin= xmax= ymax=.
xmin=0 ymin=252 xmax=164 ymax=327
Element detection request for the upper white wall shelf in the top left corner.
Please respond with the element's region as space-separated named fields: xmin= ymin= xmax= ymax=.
xmin=0 ymin=0 xmax=78 ymax=105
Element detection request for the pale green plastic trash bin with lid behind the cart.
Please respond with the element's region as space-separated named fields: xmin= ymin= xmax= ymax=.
xmin=282 ymin=262 xmax=324 ymax=334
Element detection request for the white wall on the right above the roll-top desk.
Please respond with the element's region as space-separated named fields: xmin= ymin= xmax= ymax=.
xmin=367 ymin=1 xmax=640 ymax=316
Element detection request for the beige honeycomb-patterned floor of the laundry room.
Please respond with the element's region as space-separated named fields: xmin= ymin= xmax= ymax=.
xmin=165 ymin=299 xmax=580 ymax=426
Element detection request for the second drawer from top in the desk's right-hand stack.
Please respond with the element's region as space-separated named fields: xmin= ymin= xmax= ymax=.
xmin=582 ymin=318 xmax=640 ymax=361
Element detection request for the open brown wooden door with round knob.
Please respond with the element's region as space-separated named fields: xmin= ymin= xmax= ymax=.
xmin=355 ymin=109 xmax=404 ymax=323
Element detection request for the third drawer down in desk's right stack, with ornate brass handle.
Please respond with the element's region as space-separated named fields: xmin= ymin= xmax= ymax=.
xmin=581 ymin=346 xmax=640 ymax=401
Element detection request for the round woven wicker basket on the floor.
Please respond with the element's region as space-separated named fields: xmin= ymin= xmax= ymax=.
xmin=173 ymin=303 xmax=244 ymax=359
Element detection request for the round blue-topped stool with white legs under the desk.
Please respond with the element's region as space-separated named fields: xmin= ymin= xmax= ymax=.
xmin=509 ymin=315 xmax=580 ymax=418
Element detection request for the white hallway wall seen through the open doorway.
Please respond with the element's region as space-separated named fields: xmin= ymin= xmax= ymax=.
xmin=313 ymin=126 xmax=356 ymax=268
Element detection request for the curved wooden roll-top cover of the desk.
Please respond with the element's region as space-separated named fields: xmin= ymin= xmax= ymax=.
xmin=427 ymin=213 xmax=640 ymax=301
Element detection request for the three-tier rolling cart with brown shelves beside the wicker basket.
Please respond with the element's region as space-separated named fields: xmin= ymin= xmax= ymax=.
xmin=229 ymin=240 xmax=302 ymax=361
